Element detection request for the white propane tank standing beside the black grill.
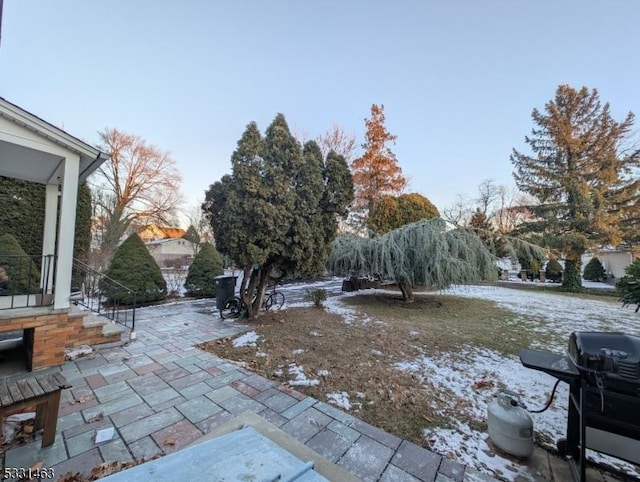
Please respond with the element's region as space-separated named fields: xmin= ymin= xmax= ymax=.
xmin=487 ymin=390 xmax=533 ymax=457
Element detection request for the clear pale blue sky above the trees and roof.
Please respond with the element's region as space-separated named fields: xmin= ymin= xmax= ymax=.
xmin=0 ymin=0 xmax=640 ymax=220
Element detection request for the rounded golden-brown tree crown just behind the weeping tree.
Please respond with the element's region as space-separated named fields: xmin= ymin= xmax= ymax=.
xmin=367 ymin=193 xmax=440 ymax=234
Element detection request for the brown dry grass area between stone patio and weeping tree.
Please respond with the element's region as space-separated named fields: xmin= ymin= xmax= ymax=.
xmin=201 ymin=288 xmax=533 ymax=446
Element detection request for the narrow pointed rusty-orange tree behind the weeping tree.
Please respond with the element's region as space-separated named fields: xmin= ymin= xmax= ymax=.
xmin=351 ymin=104 xmax=407 ymax=225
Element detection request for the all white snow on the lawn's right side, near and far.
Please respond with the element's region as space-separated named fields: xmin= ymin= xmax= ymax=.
xmin=396 ymin=286 xmax=640 ymax=480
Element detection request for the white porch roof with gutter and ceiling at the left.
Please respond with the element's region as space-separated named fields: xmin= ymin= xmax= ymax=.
xmin=0 ymin=97 xmax=109 ymax=184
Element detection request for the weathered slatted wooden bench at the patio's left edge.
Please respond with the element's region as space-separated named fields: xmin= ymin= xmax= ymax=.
xmin=0 ymin=373 xmax=71 ymax=447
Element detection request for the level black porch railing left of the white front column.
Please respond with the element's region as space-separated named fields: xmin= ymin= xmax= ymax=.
xmin=0 ymin=254 xmax=55 ymax=310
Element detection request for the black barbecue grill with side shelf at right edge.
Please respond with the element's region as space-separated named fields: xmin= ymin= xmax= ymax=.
xmin=520 ymin=332 xmax=640 ymax=482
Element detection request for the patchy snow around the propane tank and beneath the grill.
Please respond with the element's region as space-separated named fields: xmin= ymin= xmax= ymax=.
xmin=395 ymin=349 xmax=640 ymax=480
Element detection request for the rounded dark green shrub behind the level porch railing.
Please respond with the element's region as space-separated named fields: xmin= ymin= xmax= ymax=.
xmin=0 ymin=234 xmax=40 ymax=294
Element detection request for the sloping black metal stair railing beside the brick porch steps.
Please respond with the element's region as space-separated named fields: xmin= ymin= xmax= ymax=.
xmin=71 ymin=258 xmax=136 ymax=331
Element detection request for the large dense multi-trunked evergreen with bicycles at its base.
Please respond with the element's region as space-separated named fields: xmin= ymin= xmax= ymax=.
xmin=203 ymin=114 xmax=353 ymax=317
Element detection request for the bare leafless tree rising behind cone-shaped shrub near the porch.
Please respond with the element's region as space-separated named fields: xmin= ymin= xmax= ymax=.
xmin=92 ymin=129 xmax=182 ymax=260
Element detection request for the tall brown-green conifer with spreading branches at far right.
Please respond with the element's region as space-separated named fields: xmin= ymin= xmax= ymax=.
xmin=511 ymin=85 xmax=640 ymax=291
